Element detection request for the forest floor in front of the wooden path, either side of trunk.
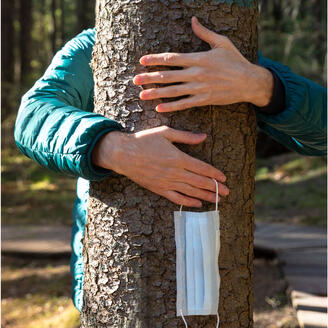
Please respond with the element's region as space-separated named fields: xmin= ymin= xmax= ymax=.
xmin=1 ymin=256 xmax=298 ymax=328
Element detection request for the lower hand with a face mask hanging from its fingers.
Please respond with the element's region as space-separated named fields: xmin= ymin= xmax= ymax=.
xmin=92 ymin=126 xmax=229 ymax=207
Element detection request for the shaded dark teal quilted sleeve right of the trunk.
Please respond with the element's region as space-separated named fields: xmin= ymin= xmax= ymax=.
xmin=256 ymin=55 xmax=327 ymax=156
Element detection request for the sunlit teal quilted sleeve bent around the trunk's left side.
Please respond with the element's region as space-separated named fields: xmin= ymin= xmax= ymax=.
xmin=15 ymin=29 xmax=121 ymax=180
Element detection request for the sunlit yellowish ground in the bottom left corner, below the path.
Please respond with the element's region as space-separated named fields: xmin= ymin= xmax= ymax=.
xmin=1 ymin=257 xmax=79 ymax=328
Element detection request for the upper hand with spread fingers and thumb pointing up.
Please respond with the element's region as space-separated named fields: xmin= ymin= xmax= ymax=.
xmin=133 ymin=17 xmax=274 ymax=112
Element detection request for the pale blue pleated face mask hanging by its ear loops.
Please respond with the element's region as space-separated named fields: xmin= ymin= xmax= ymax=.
xmin=174 ymin=179 xmax=220 ymax=327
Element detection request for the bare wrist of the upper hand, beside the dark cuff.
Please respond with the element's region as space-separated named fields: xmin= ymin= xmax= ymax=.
xmin=247 ymin=64 xmax=274 ymax=107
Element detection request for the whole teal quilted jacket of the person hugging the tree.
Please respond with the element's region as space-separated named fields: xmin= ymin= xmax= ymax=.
xmin=15 ymin=29 xmax=327 ymax=310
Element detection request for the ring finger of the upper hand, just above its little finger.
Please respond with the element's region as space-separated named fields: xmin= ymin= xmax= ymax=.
xmin=140 ymin=82 xmax=203 ymax=100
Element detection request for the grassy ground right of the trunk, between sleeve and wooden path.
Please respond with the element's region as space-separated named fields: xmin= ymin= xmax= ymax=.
xmin=255 ymin=153 xmax=327 ymax=227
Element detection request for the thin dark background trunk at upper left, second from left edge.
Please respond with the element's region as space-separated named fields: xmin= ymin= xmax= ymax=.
xmin=19 ymin=0 xmax=32 ymax=87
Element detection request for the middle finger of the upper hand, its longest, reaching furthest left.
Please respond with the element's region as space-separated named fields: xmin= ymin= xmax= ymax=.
xmin=133 ymin=67 xmax=194 ymax=85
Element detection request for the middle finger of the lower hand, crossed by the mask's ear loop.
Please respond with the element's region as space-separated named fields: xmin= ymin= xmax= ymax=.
xmin=179 ymin=170 xmax=229 ymax=197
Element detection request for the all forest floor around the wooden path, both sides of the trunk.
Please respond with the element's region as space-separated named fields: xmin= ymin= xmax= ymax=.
xmin=2 ymin=118 xmax=327 ymax=328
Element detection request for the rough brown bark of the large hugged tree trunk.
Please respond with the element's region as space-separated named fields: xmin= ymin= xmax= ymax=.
xmin=81 ymin=0 xmax=258 ymax=328
